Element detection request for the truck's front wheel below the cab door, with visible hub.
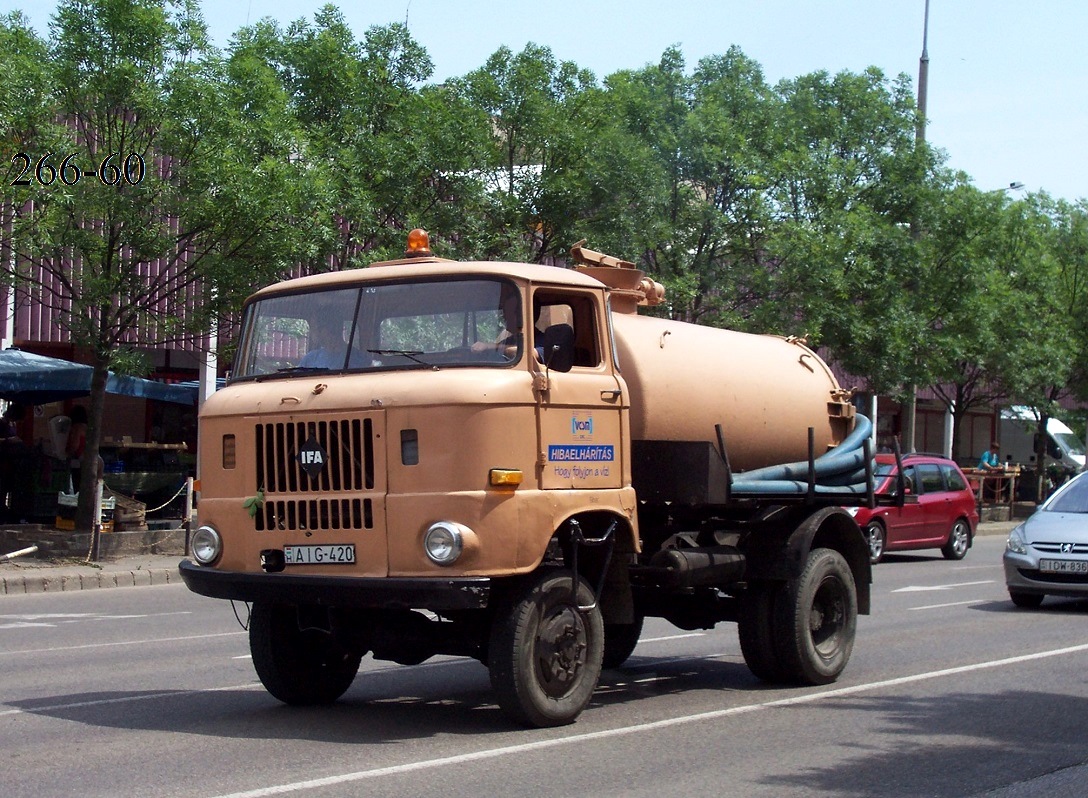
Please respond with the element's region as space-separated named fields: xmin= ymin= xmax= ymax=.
xmin=487 ymin=570 xmax=604 ymax=726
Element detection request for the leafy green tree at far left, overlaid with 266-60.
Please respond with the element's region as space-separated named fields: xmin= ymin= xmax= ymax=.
xmin=0 ymin=0 xmax=320 ymax=529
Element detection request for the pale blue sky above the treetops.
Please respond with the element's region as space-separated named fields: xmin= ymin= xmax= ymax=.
xmin=8 ymin=0 xmax=1088 ymax=201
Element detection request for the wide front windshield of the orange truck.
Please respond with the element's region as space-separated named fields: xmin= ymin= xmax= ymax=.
xmin=235 ymin=279 xmax=521 ymax=379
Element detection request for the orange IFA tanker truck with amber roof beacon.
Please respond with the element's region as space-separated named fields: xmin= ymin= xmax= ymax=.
xmin=181 ymin=231 xmax=874 ymax=726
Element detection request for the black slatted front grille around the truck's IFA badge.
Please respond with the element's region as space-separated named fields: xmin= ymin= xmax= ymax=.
xmin=254 ymin=417 xmax=374 ymax=530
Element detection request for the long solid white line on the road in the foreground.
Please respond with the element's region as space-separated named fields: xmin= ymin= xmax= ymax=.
xmin=205 ymin=643 xmax=1088 ymax=798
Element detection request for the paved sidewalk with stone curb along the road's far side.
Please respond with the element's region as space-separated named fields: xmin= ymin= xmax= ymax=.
xmin=0 ymin=521 xmax=1019 ymax=597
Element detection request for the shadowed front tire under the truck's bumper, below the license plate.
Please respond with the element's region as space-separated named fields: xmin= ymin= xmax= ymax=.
xmin=249 ymin=602 xmax=362 ymax=707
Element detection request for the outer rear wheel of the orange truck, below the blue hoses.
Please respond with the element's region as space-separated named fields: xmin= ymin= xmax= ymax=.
xmin=774 ymin=549 xmax=857 ymax=685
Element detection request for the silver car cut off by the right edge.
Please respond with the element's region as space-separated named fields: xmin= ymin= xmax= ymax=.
xmin=1004 ymin=474 xmax=1088 ymax=607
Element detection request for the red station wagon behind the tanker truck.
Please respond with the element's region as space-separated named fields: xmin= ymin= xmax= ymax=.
xmin=846 ymin=454 xmax=978 ymax=563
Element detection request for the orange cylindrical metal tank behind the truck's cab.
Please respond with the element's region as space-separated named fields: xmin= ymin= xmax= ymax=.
xmin=571 ymin=245 xmax=855 ymax=476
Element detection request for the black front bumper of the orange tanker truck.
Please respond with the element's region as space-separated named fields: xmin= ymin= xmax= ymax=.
xmin=178 ymin=560 xmax=492 ymax=612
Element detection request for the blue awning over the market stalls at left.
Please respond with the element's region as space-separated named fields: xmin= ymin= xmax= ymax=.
xmin=0 ymin=349 xmax=197 ymax=405
